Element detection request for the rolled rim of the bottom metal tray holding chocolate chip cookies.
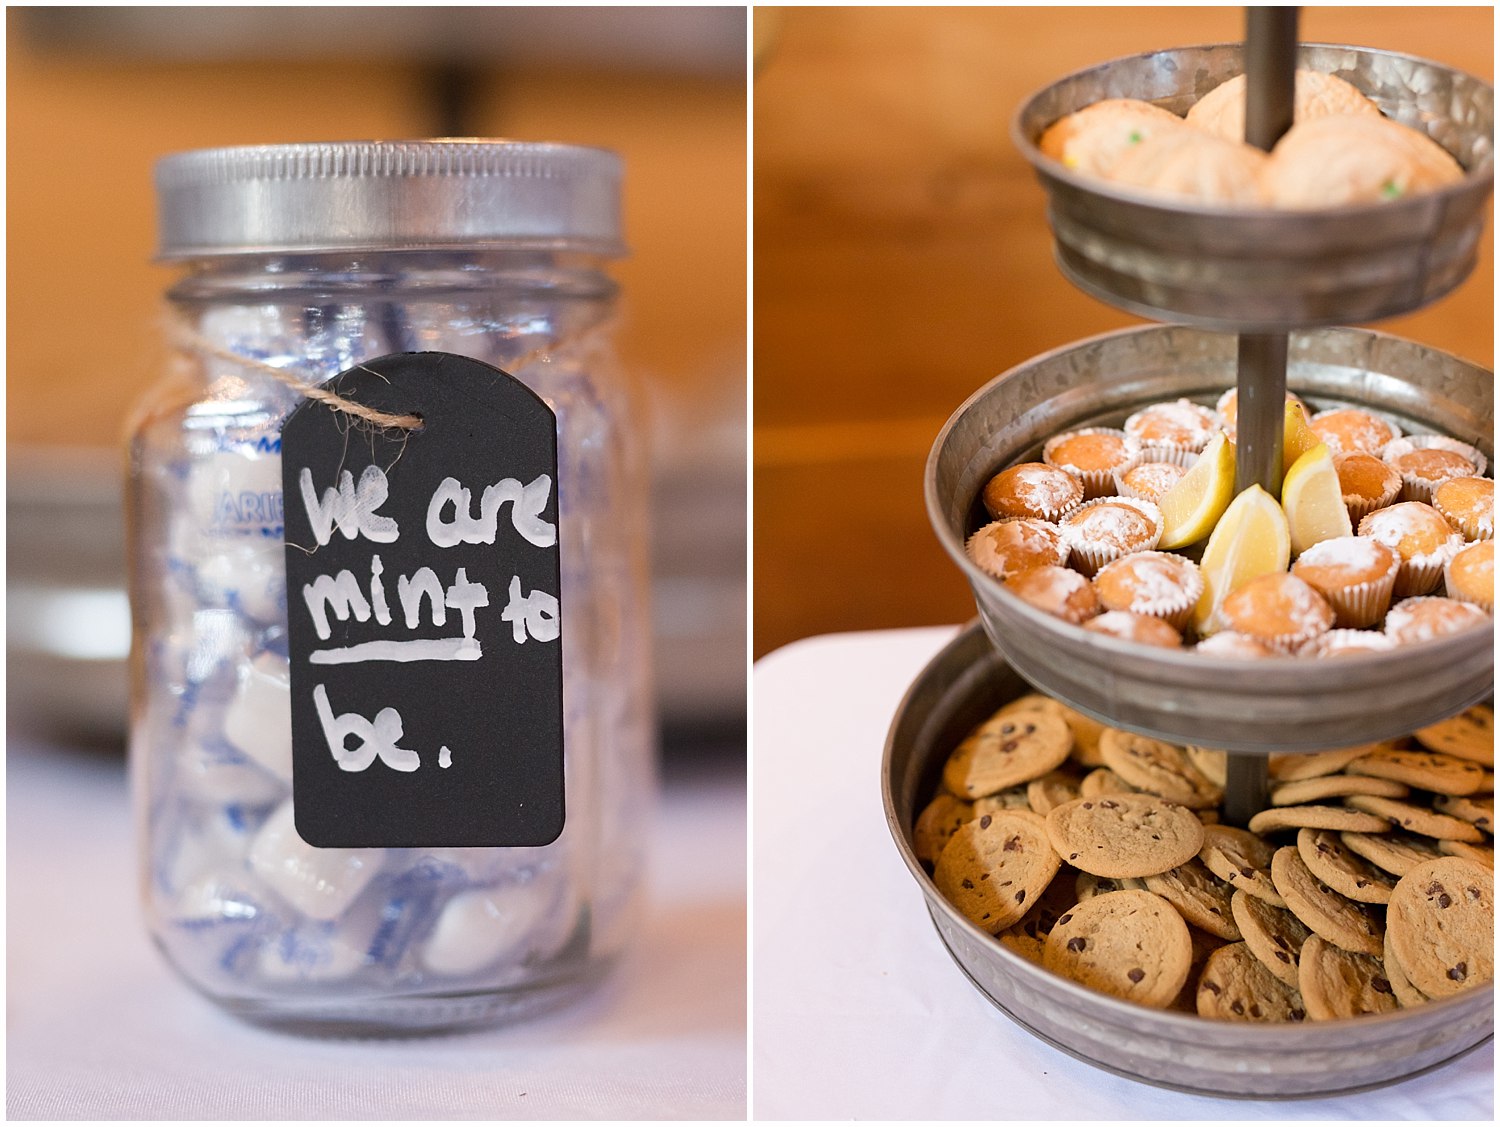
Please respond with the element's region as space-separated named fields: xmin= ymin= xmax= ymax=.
xmin=881 ymin=620 xmax=1494 ymax=1044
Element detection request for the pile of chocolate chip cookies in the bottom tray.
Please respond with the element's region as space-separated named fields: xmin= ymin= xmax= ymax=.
xmin=915 ymin=695 xmax=1494 ymax=1022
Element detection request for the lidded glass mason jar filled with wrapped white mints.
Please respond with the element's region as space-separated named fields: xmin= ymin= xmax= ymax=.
xmin=129 ymin=141 xmax=653 ymax=1031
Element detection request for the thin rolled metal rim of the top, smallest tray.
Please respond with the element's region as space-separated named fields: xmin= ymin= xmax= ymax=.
xmin=1010 ymin=44 xmax=1494 ymax=220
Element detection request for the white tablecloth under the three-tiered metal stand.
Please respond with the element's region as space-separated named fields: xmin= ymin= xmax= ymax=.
xmin=752 ymin=627 xmax=1494 ymax=1122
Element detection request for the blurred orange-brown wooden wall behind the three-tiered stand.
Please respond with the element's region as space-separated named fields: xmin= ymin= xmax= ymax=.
xmin=753 ymin=6 xmax=1494 ymax=654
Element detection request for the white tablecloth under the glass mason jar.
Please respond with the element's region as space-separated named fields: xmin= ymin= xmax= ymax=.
xmin=6 ymin=738 xmax=747 ymax=1119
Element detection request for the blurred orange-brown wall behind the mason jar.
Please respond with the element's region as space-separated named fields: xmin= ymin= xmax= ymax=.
xmin=6 ymin=9 xmax=747 ymax=462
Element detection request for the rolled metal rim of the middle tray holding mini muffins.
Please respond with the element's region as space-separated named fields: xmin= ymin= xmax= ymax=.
xmin=923 ymin=326 xmax=1494 ymax=692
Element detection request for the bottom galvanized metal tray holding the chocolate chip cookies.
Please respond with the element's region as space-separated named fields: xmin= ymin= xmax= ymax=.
xmin=882 ymin=624 xmax=1494 ymax=1098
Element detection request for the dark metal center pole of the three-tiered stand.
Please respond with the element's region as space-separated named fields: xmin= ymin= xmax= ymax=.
xmin=1224 ymin=8 xmax=1299 ymax=825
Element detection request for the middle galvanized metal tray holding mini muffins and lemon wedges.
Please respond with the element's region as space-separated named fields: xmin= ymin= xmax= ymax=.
xmin=926 ymin=326 xmax=1494 ymax=752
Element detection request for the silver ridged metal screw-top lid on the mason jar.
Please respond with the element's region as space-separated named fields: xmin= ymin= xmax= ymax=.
xmin=156 ymin=138 xmax=624 ymax=260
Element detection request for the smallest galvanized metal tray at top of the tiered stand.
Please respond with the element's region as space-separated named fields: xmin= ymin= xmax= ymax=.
xmin=1011 ymin=44 xmax=1494 ymax=333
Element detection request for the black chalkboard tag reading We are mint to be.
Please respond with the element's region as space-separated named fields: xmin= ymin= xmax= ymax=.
xmin=282 ymin=353 xmax=564 ymax=848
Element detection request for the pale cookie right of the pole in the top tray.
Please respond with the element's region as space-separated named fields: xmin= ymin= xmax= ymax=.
xmin=1262 ymin=114 xmax=1464 ymax=209
